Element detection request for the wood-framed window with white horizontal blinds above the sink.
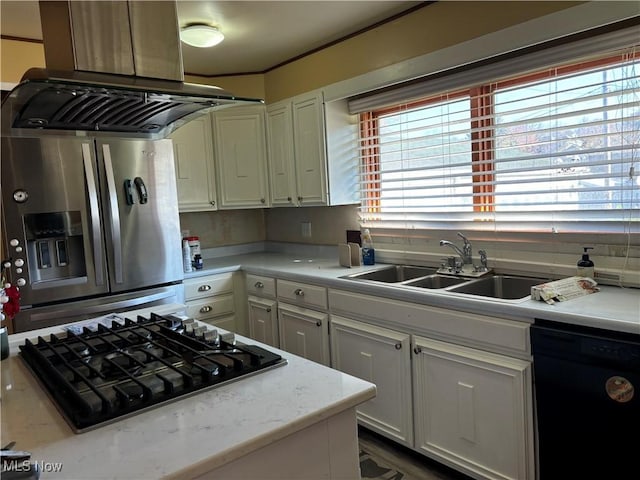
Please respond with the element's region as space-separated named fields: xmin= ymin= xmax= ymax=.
xmin=360 ymin=49 xmax=640 ymax=232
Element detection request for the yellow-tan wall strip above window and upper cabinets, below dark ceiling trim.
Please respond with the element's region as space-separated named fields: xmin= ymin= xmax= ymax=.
xmin=265 ymin=1 xmax=584 ymax=103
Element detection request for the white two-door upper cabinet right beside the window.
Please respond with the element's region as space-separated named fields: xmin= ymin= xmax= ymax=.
xmin=267 ymin=91 xmax=358 ymax=206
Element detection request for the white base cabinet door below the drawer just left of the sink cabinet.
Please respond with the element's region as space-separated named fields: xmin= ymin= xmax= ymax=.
xmin=278 ymin=303 xmax=330 ymax=366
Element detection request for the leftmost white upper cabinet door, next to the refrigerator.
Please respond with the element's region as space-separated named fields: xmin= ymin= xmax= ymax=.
xmin=169 ymin=115 xmax=217 ymax=212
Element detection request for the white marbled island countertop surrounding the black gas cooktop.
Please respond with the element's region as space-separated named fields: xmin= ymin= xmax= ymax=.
xmin=1 ymin=307 xmax=375 ymax=480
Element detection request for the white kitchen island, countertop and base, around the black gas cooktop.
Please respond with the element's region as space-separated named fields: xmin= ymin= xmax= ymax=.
xmin=0 ymin=308 xmax=375 ymax=480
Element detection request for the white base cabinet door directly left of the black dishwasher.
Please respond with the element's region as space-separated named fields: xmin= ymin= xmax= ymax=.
xmin=413 ymin=337 xmax=535 ymax=479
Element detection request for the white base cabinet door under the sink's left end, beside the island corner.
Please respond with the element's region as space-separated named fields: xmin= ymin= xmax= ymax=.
xmin=330 ymin=315 xmax=413 ymax=447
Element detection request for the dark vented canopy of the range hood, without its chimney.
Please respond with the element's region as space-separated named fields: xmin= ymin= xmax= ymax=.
xmin=2 ymin=68 xmax=262 ymax=139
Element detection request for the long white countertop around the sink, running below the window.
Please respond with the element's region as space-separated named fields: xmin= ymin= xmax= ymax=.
xmin=187 ymin=252 xmax=640 ymax=334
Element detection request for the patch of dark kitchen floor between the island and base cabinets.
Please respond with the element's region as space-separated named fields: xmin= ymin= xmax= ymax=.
xmin=358 ymin=427 xmax=470 ymax=480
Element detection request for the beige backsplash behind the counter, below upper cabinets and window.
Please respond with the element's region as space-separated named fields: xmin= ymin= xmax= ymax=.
xmin=180 ymin=205 xmax=640 ymax=287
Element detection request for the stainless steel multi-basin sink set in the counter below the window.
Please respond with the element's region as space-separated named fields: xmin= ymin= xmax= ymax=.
xmin=342 ymin=265 xmax=548 ymax=300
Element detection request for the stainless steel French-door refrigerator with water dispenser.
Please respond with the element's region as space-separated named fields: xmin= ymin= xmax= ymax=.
xmin=1 ymin=135 xmax=183 ymax=332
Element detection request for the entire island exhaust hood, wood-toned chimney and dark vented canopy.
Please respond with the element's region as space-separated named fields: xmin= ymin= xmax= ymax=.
xmin=2 ymin=1 xmax=263 ymax=139
